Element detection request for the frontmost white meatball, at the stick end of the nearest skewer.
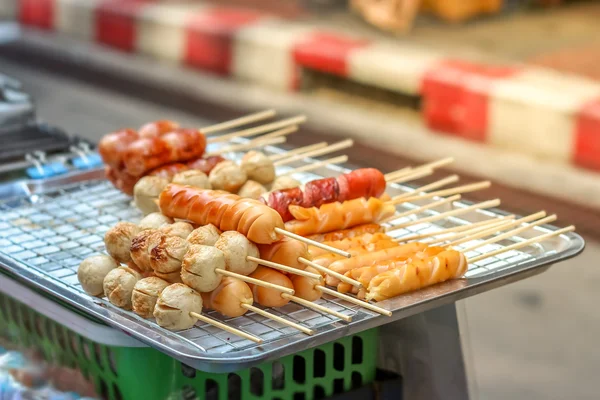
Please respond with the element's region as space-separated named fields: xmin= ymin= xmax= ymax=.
xmin=154 ymin=283 xmax=202 ymax=331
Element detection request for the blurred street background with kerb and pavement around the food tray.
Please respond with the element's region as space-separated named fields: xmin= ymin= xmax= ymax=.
xmin=0 ymin=0 xmax=600 ymax=399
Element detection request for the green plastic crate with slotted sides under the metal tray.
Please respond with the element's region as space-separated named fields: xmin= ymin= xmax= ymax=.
xmin=0 ymin=293 xmax=378 ymax=400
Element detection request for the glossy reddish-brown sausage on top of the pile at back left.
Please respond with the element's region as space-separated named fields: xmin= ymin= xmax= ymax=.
xmin=123 ymin=128 xmax=206 ymax=176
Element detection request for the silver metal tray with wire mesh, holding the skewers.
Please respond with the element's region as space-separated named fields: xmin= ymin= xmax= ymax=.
xmin=0 ymin=148 xmax=584 ymax=372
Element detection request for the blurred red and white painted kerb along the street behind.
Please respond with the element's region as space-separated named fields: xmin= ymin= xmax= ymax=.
xmin=0 ymin=0 xmax=600 ymax=170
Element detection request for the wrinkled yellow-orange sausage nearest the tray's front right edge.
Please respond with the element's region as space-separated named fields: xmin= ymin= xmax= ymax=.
xmin=366 ymin=250 xmax=468 ymax=301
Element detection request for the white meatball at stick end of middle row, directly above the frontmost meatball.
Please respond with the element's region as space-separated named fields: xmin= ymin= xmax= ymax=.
xmin=181 ymin=245 xmax=225 ymax=292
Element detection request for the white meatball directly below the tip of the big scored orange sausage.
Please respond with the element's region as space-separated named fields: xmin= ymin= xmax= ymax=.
xmin=215 ymin=231 xmax=260 ymax=275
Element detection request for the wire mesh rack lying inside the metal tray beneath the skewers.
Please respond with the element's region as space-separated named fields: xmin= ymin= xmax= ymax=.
xmin=0 ymin=174 xmax=556 ymax=353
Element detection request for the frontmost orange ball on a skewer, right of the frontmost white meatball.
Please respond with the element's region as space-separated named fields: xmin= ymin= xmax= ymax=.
xmin=202 ymin=276 xmax=254 ymax=318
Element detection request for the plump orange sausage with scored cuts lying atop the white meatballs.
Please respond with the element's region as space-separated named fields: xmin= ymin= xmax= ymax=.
xmin=159 ymin=184 xmax=284 ymax=243
